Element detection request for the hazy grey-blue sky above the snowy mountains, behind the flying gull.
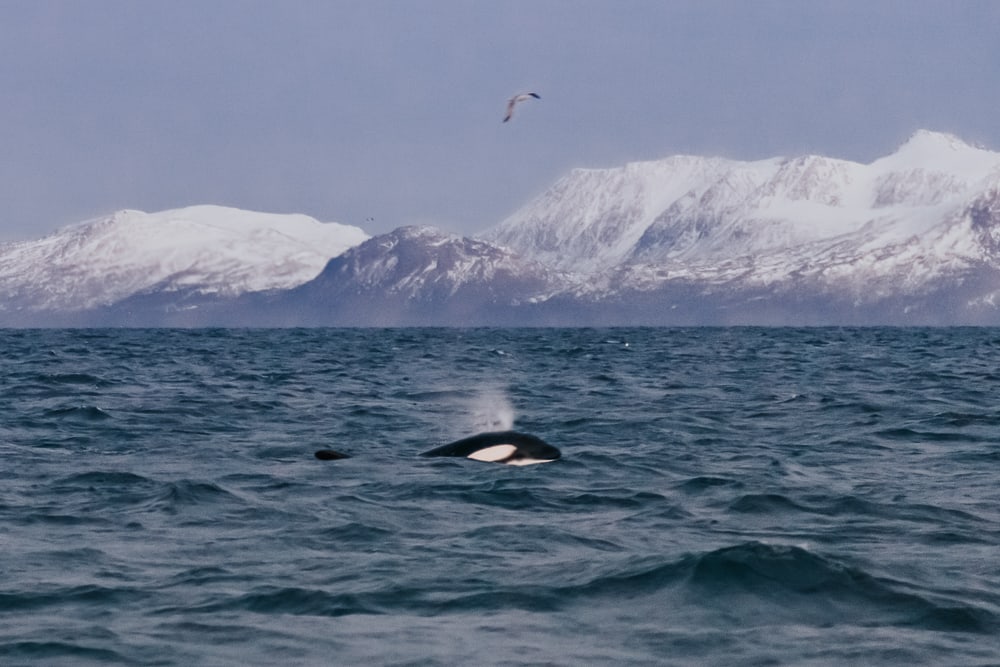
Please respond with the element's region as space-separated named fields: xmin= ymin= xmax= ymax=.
xmin=0 ymin=0 xmax=1000 ymax=241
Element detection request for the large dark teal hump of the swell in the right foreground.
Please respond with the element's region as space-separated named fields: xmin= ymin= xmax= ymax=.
xmin=563 ymin=542 xmax=1000 ymax=634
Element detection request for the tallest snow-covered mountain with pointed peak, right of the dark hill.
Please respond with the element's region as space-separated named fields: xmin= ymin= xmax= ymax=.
xmin=482 ymin=131 xmax=1000 ymax=320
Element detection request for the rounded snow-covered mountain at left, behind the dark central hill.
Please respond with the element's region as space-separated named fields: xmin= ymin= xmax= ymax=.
xmin=0 ymin=206 xmax=368 ymax=317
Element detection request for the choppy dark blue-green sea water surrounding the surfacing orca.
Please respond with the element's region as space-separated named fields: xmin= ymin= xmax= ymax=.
xmin=0 ymin=328 xmax=1000 ymax=665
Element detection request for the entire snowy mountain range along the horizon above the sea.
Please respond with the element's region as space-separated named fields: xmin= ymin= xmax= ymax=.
xmin=0 ymin=131 xmax=1000 ymax=326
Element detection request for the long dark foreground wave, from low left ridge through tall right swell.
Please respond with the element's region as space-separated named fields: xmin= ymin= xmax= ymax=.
xmin=137 ymin=542 xmax=1000 ymax=635
